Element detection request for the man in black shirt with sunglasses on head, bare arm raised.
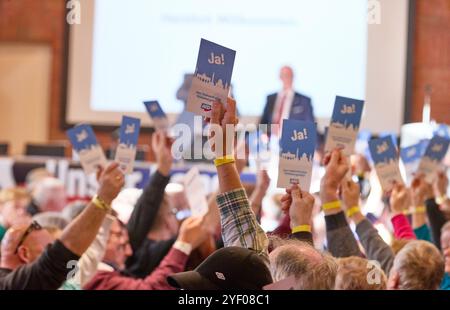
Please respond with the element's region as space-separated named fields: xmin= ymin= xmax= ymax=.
xmin=0 ymin=163 xmax=124 ymax=290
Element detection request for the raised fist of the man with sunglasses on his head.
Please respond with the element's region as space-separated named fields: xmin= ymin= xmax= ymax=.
xmin=97 ymin=162 xmax=125 ymax=205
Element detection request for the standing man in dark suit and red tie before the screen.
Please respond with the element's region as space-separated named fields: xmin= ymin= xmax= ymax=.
xmin=260 ymin=66 xmax=315 ymax=135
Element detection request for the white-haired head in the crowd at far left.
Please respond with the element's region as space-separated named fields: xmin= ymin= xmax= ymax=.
xmin=33 ymin=177 xmax=67 ymax=212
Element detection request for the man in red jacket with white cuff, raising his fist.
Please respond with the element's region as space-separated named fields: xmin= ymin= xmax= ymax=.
xmin=84 ymin=213 xmax=207 ymax=290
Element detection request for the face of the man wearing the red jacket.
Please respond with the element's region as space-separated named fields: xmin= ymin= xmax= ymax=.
xmin=103 ymin=219 xmax=133 ymax=269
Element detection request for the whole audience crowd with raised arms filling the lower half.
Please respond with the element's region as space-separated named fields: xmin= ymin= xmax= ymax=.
xmin=0 ymin=100 xmax=450 ymax=290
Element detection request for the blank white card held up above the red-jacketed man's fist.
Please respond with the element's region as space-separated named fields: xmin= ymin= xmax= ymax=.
xmin=183 ymin=167 xmax=209 ymax=216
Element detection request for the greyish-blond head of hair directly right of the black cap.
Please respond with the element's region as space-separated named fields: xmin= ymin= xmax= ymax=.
xmin=269 ymin=240 xmax=337 ymax=290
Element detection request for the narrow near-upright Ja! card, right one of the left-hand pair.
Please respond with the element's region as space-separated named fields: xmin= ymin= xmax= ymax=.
xmin=115 ymin=116 xmax=141 ymax=174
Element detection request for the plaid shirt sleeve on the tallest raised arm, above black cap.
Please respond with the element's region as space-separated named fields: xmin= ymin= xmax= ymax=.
xmin=216 ymin=188 xmax=269 ymax=262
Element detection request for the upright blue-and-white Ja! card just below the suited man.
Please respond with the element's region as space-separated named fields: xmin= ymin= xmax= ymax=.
xmin=277 ymin=119 xmax=317 ymax=191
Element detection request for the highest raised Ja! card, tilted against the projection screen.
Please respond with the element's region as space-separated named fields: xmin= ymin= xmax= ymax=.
xmin=186 ymin=39 xmax=236 ymax=117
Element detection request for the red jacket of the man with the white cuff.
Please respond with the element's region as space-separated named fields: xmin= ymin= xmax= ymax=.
xmin=84 ymin=248 xmax=188 ymax=290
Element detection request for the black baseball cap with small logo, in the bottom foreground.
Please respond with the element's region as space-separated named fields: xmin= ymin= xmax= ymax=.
xmin=167 ymin=247 xmax=272 ymax=290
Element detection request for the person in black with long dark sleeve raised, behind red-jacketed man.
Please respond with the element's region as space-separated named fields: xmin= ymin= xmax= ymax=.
xmin=126 ymin=131 xmax=179 ymax=278
